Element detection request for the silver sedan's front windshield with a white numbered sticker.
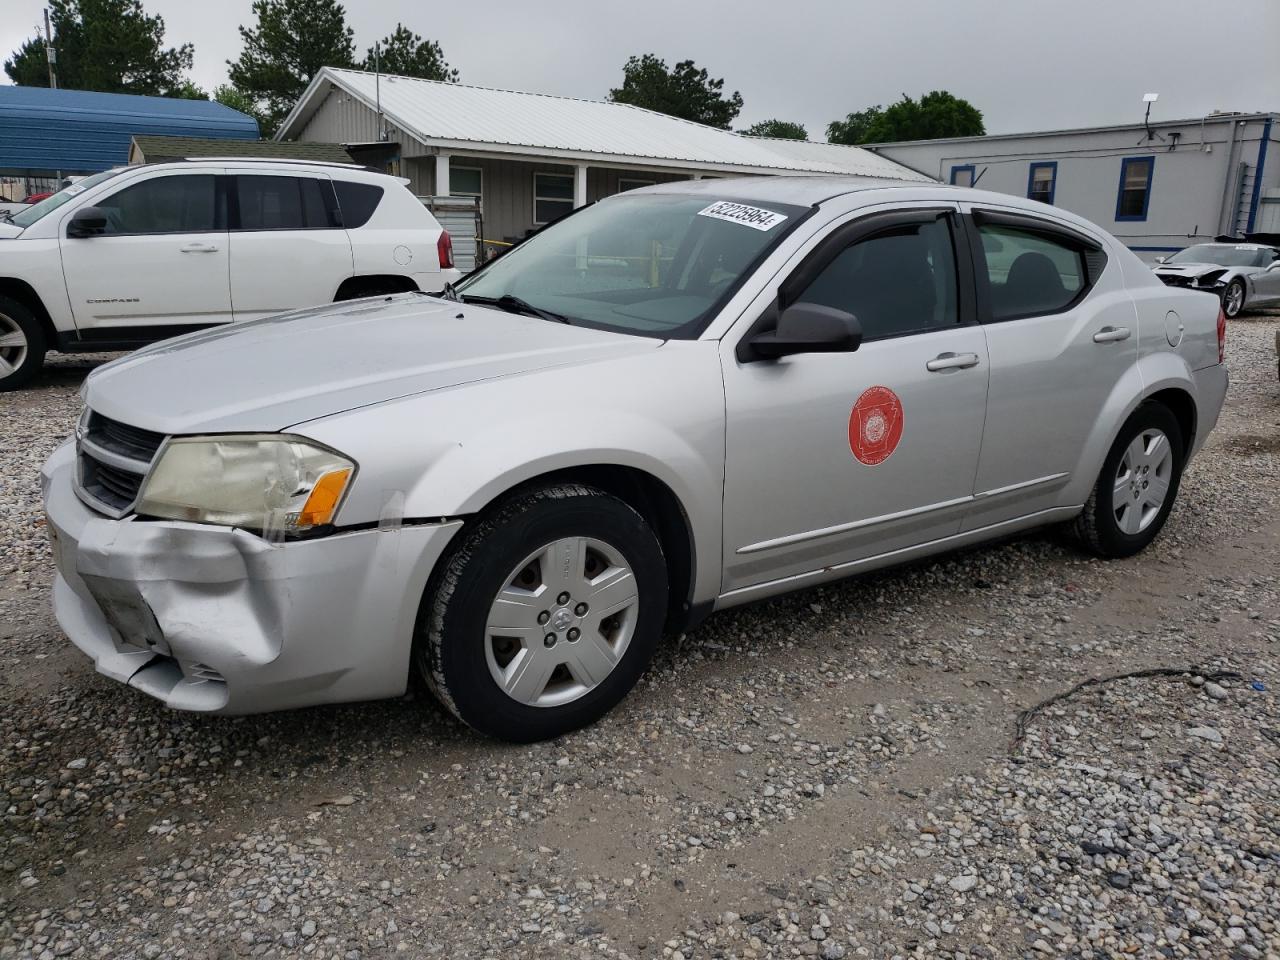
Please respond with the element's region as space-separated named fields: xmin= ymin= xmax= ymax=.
xmin=457 ymin=193 xmax=808 ymax=339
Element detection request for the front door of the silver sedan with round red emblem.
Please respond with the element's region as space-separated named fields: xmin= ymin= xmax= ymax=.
xmin=723 ymin=209 xmax=988 ymax=593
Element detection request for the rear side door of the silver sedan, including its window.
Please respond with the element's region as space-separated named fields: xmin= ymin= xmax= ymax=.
xmin=965 ymin=207 xmax=1138 ymax=530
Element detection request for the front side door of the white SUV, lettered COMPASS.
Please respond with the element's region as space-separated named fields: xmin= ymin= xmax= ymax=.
xmin=59 ymin=170 xmax=232 ymax=335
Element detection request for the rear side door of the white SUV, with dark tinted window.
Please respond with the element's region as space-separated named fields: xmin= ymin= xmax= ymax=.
xmin=229 ymin=170 xmax=352 ymax=320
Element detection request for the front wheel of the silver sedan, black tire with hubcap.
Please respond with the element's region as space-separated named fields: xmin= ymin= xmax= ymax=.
xmin=413 ymin=484 xmax=667 ymax=742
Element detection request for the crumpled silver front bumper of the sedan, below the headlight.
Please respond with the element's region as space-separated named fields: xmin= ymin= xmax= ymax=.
xmin=41 ymin=443 xmax=461 ymax=713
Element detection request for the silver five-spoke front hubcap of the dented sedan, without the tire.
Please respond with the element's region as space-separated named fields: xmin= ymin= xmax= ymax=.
xmin=485 ymin=536 xmax=640 ymax=707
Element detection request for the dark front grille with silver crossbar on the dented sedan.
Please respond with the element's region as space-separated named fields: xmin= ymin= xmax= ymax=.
xmin=76 ymin=412 xmax=165 ymax=517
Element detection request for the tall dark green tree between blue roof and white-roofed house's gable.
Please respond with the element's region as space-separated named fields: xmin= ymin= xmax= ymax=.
xmin=227 ymin=0 xmax=356 ymax=137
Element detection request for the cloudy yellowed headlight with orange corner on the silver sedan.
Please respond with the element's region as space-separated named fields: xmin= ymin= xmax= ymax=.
xmin=137 ymin=434 xmax=356 ymax=538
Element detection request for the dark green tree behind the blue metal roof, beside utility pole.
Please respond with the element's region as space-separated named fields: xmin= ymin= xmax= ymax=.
xmin=4 ymin=0 xmax=192 ymax=96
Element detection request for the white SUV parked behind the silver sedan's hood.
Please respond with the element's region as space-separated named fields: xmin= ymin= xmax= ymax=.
xmin=0 ymin=159 xmax=460 ymax=390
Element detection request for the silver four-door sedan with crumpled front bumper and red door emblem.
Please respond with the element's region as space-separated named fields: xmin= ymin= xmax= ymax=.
xmin=44 ymin=178 xmax=1228 ymax=740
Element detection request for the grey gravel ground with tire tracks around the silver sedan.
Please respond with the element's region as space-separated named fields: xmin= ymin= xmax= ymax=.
xmin=0 ymin=323 xmax=1280 ymax=960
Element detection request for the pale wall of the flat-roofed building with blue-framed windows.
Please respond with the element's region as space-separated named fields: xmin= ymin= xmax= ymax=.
xmin=877 ymin=119 xmax=1280 ymax=260
